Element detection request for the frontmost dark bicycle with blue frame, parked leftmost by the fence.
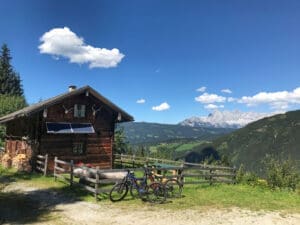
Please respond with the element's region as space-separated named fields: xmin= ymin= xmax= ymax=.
xmin=109 ymin=168 xmax=166 ymax=204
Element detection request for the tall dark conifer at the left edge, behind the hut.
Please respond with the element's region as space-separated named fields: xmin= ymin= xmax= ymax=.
xmin=0 ymin=44 xmax=24 ymax=96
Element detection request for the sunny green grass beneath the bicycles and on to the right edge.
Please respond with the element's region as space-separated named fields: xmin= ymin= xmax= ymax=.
xmin=115 ymin=184 xmax=300 ymax=213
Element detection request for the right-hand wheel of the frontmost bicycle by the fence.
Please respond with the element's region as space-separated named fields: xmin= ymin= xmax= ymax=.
xmin=147 ymin=182 xmax=166 ymax=204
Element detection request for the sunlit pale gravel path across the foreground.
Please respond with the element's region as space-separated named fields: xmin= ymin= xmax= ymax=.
xmin=0 ymin=183 xmax=300 ymax=225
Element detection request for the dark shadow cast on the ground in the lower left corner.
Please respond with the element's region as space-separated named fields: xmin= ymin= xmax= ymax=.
xmin=0 ymin=173 xmax=98 ymax=224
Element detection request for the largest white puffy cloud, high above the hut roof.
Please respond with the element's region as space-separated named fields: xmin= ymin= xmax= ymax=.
xmin=39 ymin=27 xmax=124 ymax=68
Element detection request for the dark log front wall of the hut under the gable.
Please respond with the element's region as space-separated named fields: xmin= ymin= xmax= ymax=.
xmin=39 ymin=94 xmax=117 ymax=170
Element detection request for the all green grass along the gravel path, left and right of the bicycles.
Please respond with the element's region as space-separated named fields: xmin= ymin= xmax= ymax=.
xmin=0 ymin=167 xmax=300 ymax=214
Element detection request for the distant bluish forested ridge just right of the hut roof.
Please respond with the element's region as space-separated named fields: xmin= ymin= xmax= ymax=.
xmin=119 ymin=122 xmax=234 ymax=144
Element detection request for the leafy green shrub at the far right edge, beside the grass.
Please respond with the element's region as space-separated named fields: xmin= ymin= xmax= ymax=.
xmin=264 ymin=155 xmax=300 ymax=191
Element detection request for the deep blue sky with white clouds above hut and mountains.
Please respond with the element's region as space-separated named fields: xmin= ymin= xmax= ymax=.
xmin=0 ymin=0 xmax=300 ymax=123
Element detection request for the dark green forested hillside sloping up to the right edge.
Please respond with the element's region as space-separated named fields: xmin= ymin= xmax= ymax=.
xmin=213 ymin=110 xmax=300 ymax=172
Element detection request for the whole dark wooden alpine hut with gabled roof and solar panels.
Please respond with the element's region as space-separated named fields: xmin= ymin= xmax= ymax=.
xmin=0 ymin=86 xmax=134 ymax=169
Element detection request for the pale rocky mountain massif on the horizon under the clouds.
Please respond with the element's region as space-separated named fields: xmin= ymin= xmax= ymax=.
xmin=179 ymin=110 xmax=273 ymax=128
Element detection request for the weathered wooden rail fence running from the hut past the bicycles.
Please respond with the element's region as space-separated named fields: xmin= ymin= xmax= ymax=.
xmin=54 ymin=157 xmax=236 ymax=199
